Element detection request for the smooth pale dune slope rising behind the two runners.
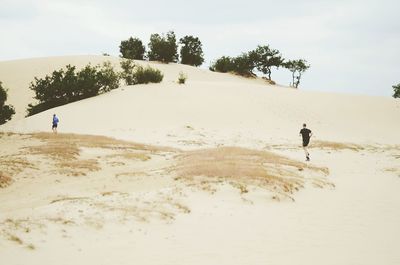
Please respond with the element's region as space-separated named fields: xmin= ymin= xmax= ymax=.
xmin=0 ymin=56 xmax=400 ymax=146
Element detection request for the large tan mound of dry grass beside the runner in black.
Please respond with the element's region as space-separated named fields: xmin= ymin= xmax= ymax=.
xmin=174 ymin=147 xmax=329 ymax=198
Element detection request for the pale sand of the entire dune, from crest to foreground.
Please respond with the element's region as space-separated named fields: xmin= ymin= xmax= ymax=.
xmin=0 ymin=56 xmax=400 ymax=265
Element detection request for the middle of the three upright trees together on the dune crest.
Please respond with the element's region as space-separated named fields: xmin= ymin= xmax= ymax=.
xmin=147 ymin=31 xmax=178 ymax=63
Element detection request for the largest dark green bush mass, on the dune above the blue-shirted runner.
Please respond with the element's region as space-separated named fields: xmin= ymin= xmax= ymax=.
xmin=28 ymin=62 xmax=119 ymax=116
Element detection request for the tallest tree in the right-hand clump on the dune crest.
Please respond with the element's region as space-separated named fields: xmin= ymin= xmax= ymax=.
xmin=249 ymin=45 xmax=284 ymax=80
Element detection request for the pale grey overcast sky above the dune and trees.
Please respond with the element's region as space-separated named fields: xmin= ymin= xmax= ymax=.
xmin=0 ymin=0 xmax=400 ymax=96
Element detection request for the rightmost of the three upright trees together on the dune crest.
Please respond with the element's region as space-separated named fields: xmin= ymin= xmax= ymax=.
xmin=179 ymin=36 xmax=204 ymax=66
